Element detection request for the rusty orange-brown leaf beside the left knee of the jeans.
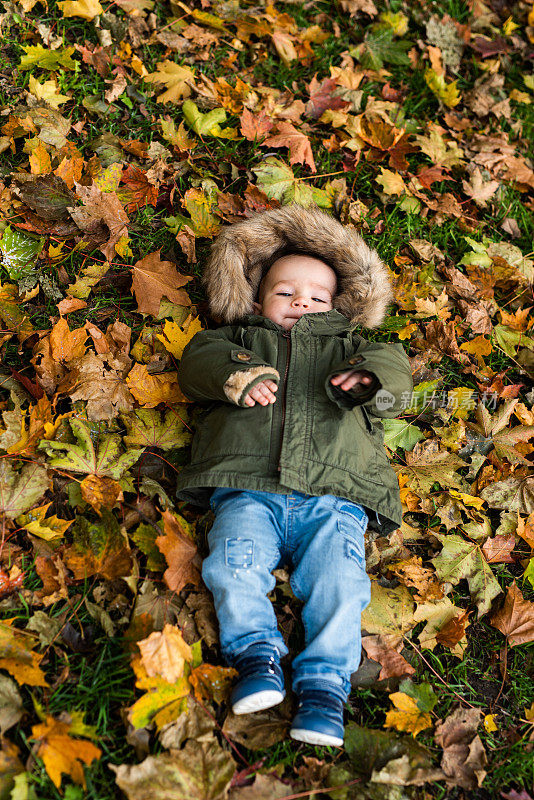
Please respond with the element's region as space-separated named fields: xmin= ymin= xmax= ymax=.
xmin=156 ymin=511 xmax=201 ymax=592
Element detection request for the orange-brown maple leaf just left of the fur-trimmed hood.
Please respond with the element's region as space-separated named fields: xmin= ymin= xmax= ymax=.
xmin=132 ymin=250 xmax=192 ymax=317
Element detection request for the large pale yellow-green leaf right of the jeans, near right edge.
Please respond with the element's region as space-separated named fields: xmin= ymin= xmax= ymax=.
xmin=432 ymin=533 xmax=501 ymax=617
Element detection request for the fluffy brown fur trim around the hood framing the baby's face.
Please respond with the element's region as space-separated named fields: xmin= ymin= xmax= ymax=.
xmin=202 ymin=203 xmax=393 ymax=328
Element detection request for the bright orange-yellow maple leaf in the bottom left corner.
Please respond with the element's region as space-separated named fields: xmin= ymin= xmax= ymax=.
xmin=32 ymin=716 xmax=102 ymax=789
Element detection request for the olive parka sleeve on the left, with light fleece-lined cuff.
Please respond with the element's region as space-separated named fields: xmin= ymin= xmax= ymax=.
xmin=178 ymin=326 xmax=280 ymax=408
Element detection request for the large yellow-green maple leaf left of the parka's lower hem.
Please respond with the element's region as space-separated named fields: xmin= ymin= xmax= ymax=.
xmin=39 ymin=418 xmax=143 ymax=480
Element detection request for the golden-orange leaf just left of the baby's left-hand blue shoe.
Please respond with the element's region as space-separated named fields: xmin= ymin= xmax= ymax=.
xmin=137 ymin=625 xmax=193 ymax=683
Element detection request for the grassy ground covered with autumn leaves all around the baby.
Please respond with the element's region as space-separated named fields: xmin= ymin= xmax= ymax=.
xmin=0 ymin=0 xmax=534 ymax=800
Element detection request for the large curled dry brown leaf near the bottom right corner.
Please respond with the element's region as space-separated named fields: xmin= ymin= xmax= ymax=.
xmin=435 ymin=708 xmax=487 ymax=789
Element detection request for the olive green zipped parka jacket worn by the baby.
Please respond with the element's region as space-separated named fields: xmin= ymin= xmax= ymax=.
xmin=177 ymin=207 xmax=413 ymax=533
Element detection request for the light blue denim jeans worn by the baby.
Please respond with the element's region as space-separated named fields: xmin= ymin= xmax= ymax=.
xmin=202 ymin=489 xmax=371 ymax=697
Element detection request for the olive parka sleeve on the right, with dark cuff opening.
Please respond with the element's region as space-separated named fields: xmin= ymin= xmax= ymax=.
xmin=325 ymin=337 xmax=413 ymax=418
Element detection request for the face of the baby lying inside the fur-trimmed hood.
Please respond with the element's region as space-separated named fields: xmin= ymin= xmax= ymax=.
xmin=254 ymin=255 xmax=337 ymax=331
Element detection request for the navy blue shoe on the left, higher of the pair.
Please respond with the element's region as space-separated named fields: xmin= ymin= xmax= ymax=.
xmin=230 ymin=642 xmax=286 ymax=714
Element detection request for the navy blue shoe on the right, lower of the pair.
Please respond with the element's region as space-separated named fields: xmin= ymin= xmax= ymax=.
xmin=289 ymin=686 xmax=344 ymax=747
